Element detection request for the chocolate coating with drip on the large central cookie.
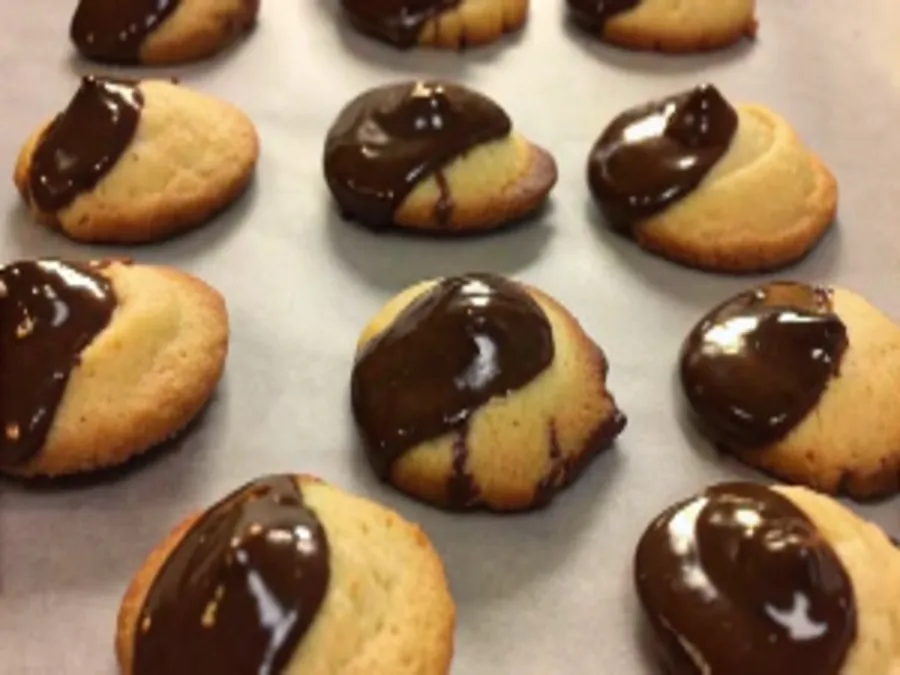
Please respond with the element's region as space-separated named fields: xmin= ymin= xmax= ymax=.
xmin=351 ymin=274 xmax=554 ymax=486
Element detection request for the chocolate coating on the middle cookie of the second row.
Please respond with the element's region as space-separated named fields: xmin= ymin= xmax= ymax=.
xmin=325 ymin=82 xmax=512 ymax=228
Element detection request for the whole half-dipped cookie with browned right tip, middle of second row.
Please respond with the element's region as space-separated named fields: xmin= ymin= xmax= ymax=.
xmin=324 ymin=81 xmax=557 ymax=234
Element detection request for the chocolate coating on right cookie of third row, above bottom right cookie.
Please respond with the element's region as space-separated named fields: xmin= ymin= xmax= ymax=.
xmin=681 ymin=282 xmax=847 ymax=448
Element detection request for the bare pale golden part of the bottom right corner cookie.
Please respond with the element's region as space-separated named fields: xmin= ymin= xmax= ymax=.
xmin=774 ymin=487 xmax=900 ymax=675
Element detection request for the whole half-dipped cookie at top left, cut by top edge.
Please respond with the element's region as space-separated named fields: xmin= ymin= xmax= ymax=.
xmin=69 ymin=0 xmax=260 ymax=65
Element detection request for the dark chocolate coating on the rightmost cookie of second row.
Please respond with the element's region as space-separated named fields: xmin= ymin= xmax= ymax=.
xmin=588 ymin=84 xmax=738 ymax=233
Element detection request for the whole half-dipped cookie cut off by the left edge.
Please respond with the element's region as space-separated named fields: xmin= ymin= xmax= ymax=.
xmin=0 ymin=260 xmax=228 ymax=477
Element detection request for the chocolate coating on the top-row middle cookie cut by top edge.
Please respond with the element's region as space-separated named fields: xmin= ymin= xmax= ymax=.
xmin=341 ymin=0 xmax=462 ymax=49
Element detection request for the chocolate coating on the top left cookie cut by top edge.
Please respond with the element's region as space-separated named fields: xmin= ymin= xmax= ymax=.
xmin=69 ymin=0 xmax=180 ymax=64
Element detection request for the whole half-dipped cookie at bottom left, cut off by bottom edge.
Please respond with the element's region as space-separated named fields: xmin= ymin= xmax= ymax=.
xmin=115 ymin=475 xmax=455 ymax=675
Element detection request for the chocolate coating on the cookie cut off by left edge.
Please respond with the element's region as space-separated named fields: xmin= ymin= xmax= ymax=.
xmin=0 ymin=260 xmax=116 ymax=466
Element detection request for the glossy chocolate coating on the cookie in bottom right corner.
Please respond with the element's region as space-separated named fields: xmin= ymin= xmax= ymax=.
xmin=635 ymin=483 xmax=857 ymax=675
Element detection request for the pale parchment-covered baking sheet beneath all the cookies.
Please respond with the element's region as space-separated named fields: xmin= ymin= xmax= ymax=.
xmin=0 ymin=0 xmax=900 ymax=675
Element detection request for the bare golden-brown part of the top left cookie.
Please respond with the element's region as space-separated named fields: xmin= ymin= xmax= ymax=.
xmin=140 ymin=0 xmax=260 ymax=65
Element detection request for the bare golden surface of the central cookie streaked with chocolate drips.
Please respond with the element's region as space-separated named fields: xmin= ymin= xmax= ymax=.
xmin=357 ymin=281 xmax=625 ymax=511
